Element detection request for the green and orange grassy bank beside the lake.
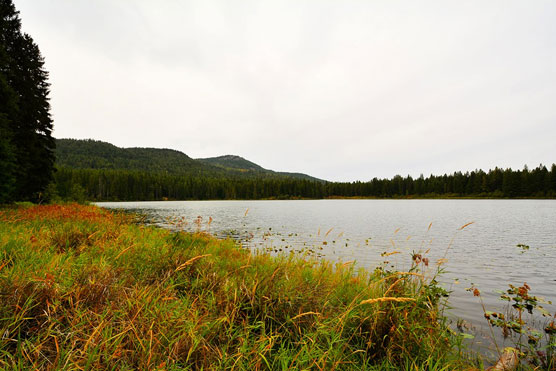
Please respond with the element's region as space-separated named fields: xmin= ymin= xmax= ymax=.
xmin=0 ymin=205 xmax=465 ymax=370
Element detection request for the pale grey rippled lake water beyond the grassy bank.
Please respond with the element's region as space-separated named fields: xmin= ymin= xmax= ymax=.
xmin=98 ymin=200 xmax=556 ymax=354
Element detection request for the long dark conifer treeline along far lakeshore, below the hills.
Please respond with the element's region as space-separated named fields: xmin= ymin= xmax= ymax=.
xmin=53 ymin=164 xmax=556 ymax=201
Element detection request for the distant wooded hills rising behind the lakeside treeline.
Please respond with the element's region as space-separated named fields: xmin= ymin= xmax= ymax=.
xmin=56 ymin=139 xmax=319 ymax=180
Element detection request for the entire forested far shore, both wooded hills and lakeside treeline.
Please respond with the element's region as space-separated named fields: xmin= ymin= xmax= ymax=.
xmin=50 ymin=139 xmax=556 ymax=201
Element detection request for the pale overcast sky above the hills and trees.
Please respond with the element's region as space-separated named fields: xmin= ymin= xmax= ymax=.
xmin=14 ymin=0 xmax=556 ymax=181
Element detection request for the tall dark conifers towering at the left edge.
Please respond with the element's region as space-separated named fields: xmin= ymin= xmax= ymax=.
xmin=0 ymin=0 xmax=55 ymax=202
